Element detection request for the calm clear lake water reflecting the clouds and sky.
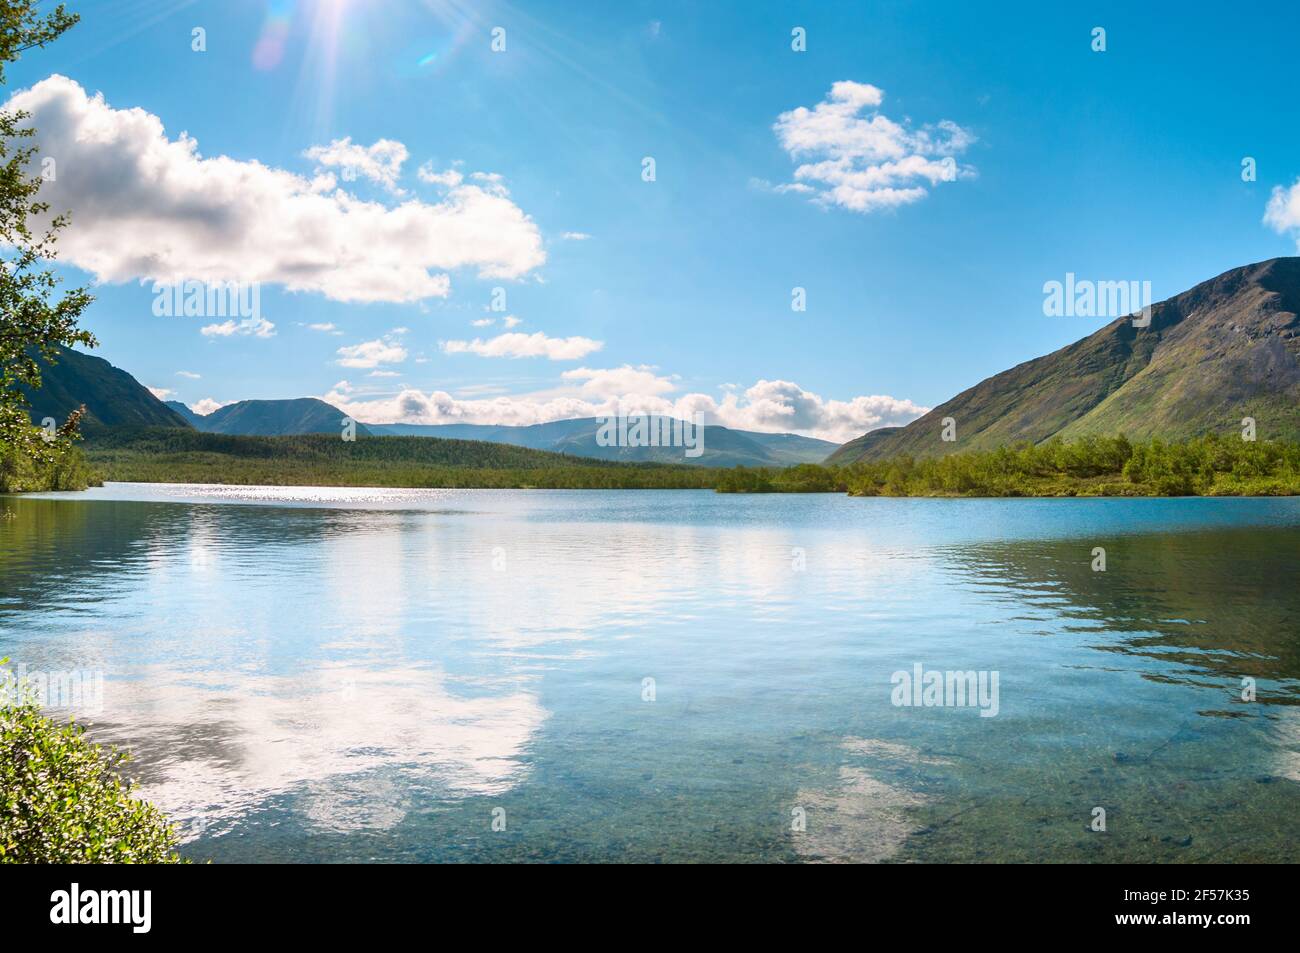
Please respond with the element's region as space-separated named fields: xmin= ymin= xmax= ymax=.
xmin=0 ymin=484 xmax=1300 ymax=862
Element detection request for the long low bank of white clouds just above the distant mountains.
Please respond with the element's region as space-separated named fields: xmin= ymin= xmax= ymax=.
xmin=322 ymin=367 xmax=930 ymax=443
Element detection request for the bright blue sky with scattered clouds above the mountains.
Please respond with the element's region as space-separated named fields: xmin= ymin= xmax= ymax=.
xmin=8 ymin=0 xmax=1300 ymax=439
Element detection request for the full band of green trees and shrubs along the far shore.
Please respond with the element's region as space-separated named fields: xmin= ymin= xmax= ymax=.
xmin=10 ymin=428 xmax=1300 ymax=497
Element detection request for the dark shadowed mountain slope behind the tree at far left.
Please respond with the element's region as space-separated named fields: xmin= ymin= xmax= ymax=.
xmin=23 ymin=347 xmax=189 ymax=432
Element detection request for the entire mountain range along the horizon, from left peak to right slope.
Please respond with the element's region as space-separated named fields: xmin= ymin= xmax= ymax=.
xmin=29 ymin=257 xmax=1300 ymax=467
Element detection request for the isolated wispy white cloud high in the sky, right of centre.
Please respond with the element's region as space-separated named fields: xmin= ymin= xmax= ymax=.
xmin=772 ymin=81 xmax=975 ymax=212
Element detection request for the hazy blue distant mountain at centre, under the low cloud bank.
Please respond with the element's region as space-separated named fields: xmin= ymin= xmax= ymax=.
xmin=365 ymin=417 xmax=836 ymax=467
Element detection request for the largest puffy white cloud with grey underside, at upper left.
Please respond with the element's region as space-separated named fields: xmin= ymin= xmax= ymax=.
xmin=5 ymin=75 xmax=546 ymax=302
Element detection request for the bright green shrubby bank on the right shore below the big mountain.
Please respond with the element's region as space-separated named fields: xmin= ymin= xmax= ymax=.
xmin=718 ymin=436 xmax=1300 ymax=497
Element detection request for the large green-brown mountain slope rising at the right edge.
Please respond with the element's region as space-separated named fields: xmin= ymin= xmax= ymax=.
xmin=827 ymin=257 xmax=1300 ymax=464
